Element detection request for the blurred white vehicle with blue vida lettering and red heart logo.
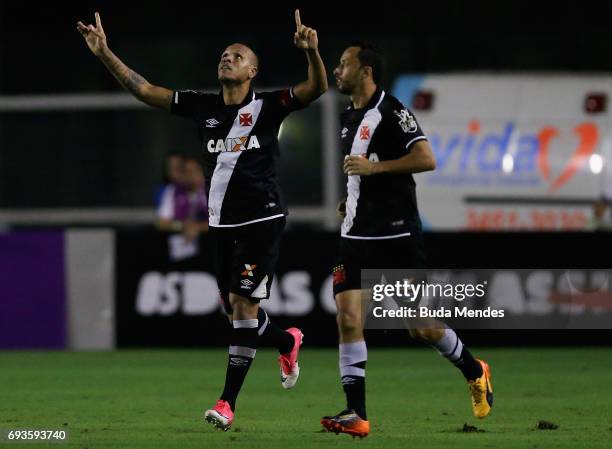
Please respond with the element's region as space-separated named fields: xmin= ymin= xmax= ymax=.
xmin=392 ymin=74 xmax=612 ymax=230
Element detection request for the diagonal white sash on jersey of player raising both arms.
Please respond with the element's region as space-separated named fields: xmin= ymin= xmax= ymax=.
xmin=208 ymin=94 xmax=263 ymax=226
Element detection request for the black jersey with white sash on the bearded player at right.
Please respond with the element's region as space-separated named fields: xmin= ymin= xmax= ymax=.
xmin=340 ymin=88 xmax=427 ymax=239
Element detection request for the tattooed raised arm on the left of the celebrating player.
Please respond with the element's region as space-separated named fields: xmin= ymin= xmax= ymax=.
xmin=77 ymin=13 xmax=172 ymax=110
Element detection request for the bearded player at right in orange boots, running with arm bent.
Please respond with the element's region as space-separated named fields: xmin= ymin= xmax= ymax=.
xmin=321 ymin=43 xmax=493 ymax=437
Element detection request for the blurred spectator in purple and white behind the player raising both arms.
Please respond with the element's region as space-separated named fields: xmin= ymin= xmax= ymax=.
xmin=157 ymin=157 xmax=208 ymax=242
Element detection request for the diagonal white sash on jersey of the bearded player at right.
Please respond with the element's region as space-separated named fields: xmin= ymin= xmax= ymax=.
xmin=341 ymin=91 xmax=385 ymax=237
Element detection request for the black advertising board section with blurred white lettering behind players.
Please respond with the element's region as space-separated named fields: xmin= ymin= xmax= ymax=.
xmin=115 ymin=231 xmax=612 ymax=347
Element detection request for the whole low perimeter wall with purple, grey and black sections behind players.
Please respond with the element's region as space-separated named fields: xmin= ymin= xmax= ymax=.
xmin=0 ymin=228 xmax=612 ymax=349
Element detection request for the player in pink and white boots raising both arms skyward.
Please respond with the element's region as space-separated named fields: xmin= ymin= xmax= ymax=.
xmin=77 ymin=10 xmax=327 ymax=430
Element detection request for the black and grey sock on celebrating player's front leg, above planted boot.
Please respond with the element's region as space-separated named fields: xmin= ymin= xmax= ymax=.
xmin=221 ymin=319 xmax=257 ymax=411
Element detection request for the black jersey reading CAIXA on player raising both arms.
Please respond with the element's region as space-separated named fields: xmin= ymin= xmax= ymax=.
xmin=171 ymin=89 xmax=303 ymax=227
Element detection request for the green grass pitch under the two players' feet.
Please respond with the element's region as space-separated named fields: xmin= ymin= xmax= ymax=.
xmin=0 ymin=341 xmax=612 ymax=449
